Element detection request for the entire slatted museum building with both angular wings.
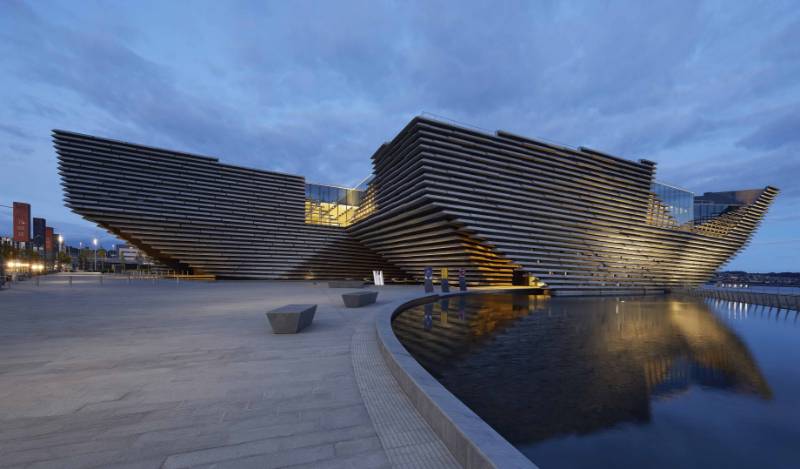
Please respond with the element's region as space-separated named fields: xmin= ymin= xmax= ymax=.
xmin=54 ymin=117 xmax=777 ymax=293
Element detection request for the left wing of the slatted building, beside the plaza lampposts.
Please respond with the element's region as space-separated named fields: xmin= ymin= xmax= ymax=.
xmin=53 ymin=130 xmax=402 ymax=280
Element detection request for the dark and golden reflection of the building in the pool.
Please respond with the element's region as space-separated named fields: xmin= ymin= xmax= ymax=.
xmin=394 ymin=295 xmax=771 ymax=443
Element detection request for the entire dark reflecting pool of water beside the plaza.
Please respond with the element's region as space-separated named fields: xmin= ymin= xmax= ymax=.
xmin=393 ymin=294 xmax=800 ymax=468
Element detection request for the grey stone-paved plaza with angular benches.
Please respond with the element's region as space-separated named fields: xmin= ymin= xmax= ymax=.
xmin=0 ymin=276 xmax=455 ymax=468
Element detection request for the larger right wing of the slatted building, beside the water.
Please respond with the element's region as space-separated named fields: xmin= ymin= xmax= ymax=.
xmin=349 ymin=118 xmax=777 ymax=293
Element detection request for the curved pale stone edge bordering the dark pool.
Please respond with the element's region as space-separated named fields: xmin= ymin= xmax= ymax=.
xmin=375 ymin=288 xmax=541 ymax=469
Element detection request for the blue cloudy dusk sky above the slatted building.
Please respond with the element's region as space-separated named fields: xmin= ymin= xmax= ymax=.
xmin=0 ymin=0 xmax=800 ymax=272
